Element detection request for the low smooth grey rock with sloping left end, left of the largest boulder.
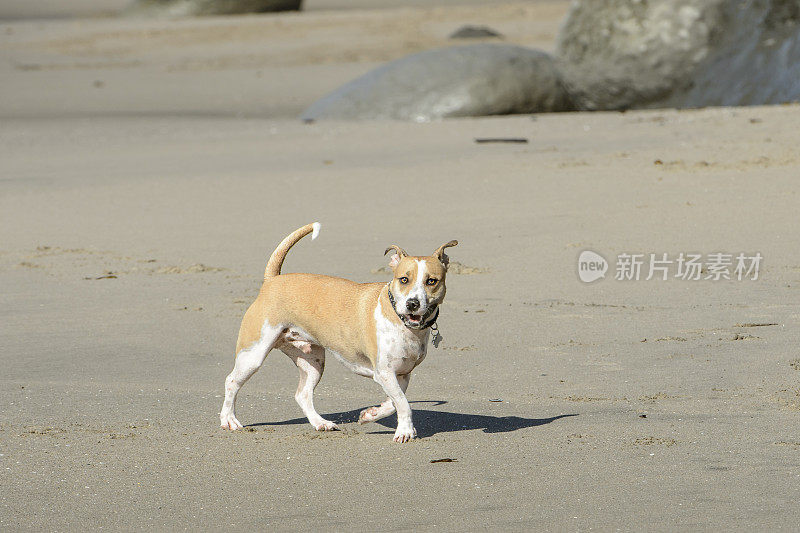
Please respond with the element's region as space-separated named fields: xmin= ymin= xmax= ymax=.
xmin=302 ymin=44 xmax=572 ymax=121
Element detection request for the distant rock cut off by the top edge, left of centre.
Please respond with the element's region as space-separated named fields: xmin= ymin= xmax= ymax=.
xmin=123 ymin=0 xmax=303 ymax=18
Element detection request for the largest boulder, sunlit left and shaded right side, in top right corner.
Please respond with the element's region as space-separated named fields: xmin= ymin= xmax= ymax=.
xmin=556 ymin=0 xmax=800 ymax=110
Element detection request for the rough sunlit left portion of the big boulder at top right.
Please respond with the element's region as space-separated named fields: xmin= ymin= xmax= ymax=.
xmin=556 ymin=0 xmax=724 ymax=110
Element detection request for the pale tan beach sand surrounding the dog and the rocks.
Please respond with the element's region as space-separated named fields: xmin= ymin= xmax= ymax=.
xmin=0 ymin=2 xmax=800 ymax=531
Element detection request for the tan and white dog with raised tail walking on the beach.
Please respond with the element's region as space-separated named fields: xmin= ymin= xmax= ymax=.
xmin=219 ymin=222 xmax=458 ymax=442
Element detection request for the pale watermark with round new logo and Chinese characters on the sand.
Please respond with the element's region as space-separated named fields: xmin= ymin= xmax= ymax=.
xmin=578 ymin=250 xmax=764 ymax=283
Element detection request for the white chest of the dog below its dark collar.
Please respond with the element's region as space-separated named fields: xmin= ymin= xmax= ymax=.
xmin=375 ymin=302 xmax=429 ymax=374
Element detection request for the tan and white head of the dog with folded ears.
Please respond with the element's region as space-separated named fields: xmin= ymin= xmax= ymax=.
xmin=384 ymin=241 xmax=458 ymax=329
